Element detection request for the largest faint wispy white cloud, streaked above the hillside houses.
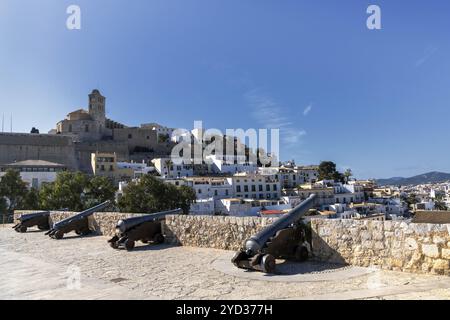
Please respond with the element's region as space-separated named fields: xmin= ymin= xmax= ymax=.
xmin=245 ymin=89 xmax=306 ymax=145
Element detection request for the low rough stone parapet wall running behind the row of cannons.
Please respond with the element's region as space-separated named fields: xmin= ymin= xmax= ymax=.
xmin=14 ymin=211 xmax=450 ymax=275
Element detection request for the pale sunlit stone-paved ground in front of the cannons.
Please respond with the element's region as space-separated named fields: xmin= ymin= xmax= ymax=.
xmin=0 ymin=226 xmax=450 ymax=300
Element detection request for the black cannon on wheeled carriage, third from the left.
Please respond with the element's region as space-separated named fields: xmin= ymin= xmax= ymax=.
xmin=108 ymin=209 xmax=183 ymax=251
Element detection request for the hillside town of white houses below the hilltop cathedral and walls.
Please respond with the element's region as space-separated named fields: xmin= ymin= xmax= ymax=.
xmin=0 ymin=89 xmax=450 ymax=221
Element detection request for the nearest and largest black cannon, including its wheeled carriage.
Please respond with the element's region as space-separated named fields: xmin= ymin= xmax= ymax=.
xmin=231 ymin=194 xmax=316 ymax=273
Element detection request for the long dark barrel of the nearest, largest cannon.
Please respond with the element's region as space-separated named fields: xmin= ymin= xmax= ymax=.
xmin=245 ymin=194 xmax=316 ymax=256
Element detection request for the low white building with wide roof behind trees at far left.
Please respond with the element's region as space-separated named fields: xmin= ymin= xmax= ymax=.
xmin=0 ymin=160 xmax=67 ymax=189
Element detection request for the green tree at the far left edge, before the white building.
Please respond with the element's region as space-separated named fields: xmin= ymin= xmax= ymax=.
xmin=0 ymin=169 xmax=28 ymax=213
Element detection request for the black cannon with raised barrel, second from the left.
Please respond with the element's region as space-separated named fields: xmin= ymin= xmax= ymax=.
xmin=45 ymin=201 xmax=111 ymax=239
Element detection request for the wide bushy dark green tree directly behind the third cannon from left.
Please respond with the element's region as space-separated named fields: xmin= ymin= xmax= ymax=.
xmin=118 ymin=175 xmax=196 ymax=214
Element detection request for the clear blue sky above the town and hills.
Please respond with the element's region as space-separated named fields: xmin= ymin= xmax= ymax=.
xmin=0 ymin=0 xmax=450 ymax=178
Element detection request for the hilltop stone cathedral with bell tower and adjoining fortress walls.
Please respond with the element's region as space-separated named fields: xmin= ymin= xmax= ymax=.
xmin=0 ymin=90 xmax=173 ymax=173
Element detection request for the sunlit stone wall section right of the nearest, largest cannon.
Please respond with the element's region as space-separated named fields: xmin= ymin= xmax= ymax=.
xmin=311 ymin=219 xmax=450 ymax=275
